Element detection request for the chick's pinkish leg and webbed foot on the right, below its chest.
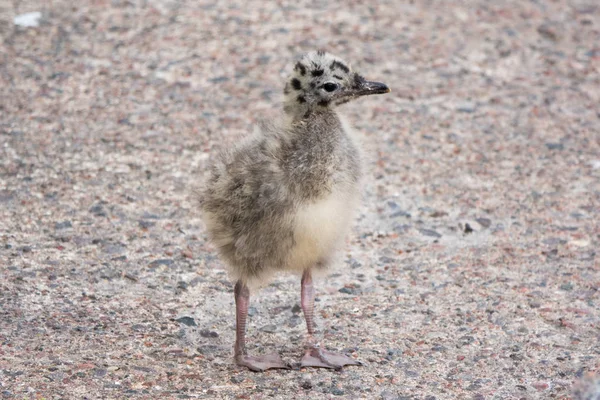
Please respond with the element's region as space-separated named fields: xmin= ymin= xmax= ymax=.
xmin=300 ymin=269 xmax=361 ymax=369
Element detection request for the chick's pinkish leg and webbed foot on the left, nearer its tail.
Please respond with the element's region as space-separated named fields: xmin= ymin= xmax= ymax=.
xmin=234 ymin=280 xmax=289 ymax=372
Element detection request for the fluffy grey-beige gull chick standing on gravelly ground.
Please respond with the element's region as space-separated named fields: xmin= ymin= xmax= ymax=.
xmin=199 ymin=50 xmax=390 ymax=371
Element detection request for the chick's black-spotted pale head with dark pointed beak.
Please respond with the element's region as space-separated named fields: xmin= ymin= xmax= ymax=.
xmin=283 ymin=50 xmax=390 ymax=117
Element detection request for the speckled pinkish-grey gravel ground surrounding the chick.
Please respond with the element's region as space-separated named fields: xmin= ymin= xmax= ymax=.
xmin=0 ymin=0 xmax=600 ymax=400
